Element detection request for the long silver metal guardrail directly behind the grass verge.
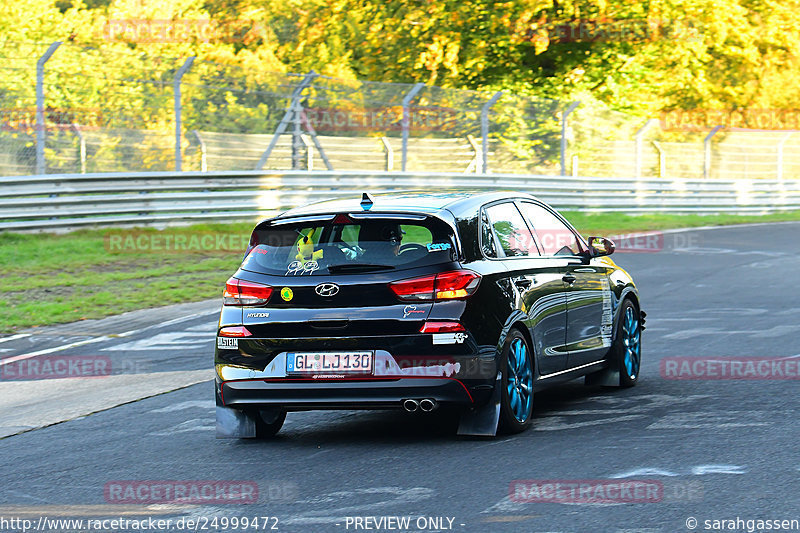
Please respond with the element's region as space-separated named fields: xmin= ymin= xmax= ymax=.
xmin=0 ymin=171 xmax=800 ymax=230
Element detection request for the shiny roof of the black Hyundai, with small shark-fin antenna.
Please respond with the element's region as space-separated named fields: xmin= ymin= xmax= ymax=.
xmin=277 ymin=190 xmax=535 ymax=218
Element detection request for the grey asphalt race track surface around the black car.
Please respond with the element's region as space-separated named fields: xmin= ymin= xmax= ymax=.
xmin=0 ymin=223 xmax=800 ymax=532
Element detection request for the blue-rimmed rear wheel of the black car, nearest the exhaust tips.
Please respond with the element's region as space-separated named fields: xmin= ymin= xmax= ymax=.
xmin=498 ymin=329 xmax=533 ymax=433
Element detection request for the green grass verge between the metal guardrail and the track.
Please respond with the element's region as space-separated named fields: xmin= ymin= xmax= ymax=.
xmin=0 ymin=211 xmax=800 ymax=333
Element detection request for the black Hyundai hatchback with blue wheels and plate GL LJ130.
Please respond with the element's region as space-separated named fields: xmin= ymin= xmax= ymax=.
xmin=215 ymin=192 xmax=644 ymax=437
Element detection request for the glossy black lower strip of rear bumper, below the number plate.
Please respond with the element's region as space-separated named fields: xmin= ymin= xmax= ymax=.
xmin=217 ymin=377 xmax=482 ymax=410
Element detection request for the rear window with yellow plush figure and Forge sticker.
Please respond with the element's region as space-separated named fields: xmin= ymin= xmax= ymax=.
xmin=242 ymin=215 xmax=458 ymax=276
